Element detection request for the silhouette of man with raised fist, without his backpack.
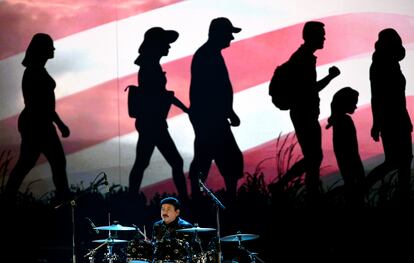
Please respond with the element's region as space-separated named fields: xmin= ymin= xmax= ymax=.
xmin=278 ymin=21 xmax=340 ymax=204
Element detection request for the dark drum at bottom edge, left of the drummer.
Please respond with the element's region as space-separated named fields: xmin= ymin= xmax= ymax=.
xmin=127 ymin=239 xmax=153 ymax=263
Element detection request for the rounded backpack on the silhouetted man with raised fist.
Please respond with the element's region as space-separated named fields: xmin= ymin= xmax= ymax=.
xmin=269 ymin=60 xmax=294 ymax=110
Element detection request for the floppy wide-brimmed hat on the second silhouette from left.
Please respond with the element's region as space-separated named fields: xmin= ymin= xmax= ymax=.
xmin=138 ymin=27 xmax=179 ymax=53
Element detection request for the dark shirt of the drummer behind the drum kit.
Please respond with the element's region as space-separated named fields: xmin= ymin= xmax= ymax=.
xmin=152 ymin=217 xmax=193 ymax=241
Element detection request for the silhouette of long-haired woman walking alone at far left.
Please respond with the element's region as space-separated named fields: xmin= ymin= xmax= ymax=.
xmin=5 ymin=33 xmax=70 ymax=203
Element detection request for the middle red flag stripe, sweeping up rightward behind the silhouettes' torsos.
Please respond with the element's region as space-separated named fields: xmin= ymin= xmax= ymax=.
xmin=0 ymin=14 xmax=414 ymax=169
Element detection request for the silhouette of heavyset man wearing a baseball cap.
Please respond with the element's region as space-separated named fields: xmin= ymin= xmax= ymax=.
xmin=190 ymin=17 xmax=244 ymax=199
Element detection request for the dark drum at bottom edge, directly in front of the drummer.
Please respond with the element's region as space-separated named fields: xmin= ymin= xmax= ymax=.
xmin=154 ymin=239 xmax=190 ymax=263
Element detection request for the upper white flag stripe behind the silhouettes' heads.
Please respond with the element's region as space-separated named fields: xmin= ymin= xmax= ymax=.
xmin=0 ymin=0 xmax=414 ymax=119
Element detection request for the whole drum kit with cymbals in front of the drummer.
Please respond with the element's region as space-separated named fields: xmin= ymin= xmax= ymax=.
xmin=84 ymin=224 xmax=263 ymax=263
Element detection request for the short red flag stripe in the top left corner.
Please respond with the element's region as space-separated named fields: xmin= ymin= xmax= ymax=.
xmin=0 ymin=0 xmax=181 ymax=59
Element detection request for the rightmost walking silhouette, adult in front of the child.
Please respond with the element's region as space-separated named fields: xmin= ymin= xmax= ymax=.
xmin=367 ymin=28 xmax=413 ymax=202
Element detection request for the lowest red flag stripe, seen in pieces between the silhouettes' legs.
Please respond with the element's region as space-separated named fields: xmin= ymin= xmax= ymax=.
xmin=143 ymin=99 xmax=414 ymax=197
